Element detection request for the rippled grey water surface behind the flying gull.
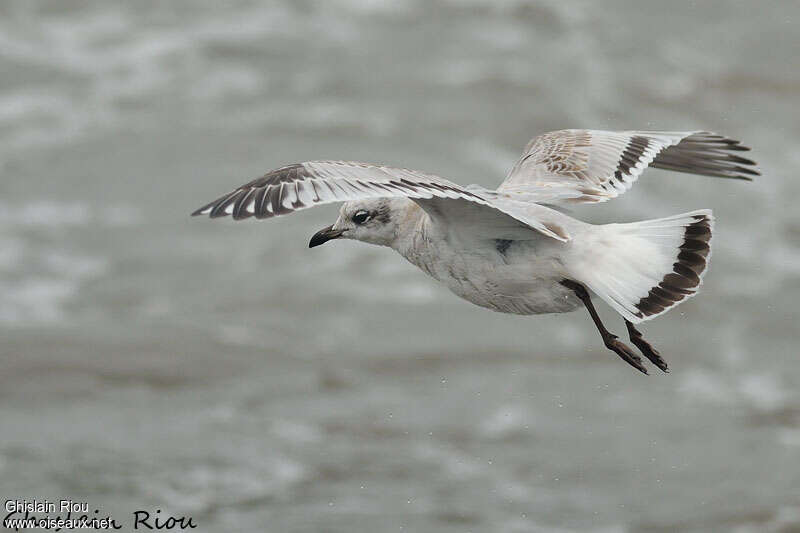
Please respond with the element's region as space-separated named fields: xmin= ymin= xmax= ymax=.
xmin=0 ymin=0 xmax=800 ymax=533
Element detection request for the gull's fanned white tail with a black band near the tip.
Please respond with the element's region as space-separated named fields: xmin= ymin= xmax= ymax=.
xmin=571 ymin=209 xmax=714 ymax=323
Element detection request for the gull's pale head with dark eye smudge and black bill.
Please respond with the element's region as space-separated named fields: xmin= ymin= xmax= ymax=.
xmin=308 ymin=198 xmax=406 ymax=248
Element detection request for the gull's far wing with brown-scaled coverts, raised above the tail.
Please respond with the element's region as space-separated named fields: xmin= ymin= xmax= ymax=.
xmin=498 ymin=130 xmax=760 ymax=203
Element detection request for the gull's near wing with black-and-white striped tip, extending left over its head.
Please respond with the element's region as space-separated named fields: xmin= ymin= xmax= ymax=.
xmin=192 ymin=161 xmax=570 ymax=241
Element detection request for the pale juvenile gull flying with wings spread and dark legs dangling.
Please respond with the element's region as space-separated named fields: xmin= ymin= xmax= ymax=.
xmin=192 ymin=129 xmax=760 ymax=374
